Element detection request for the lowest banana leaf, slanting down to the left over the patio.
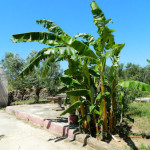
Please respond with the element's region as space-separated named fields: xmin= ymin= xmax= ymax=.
xmin=60 ymin=101 xmax=83 ymax=116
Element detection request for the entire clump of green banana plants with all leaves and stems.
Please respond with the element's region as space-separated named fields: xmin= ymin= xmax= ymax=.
xmin=12 ymin=0 xmax=150 ymax=135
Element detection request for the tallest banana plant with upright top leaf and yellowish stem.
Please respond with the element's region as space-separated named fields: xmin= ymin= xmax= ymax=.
xmin=75 ymin=1 xmax=124 ymax=135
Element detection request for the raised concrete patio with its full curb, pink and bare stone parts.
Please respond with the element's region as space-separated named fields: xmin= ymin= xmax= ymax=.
xmin=6 ymin=103 xmax=120 ymax=150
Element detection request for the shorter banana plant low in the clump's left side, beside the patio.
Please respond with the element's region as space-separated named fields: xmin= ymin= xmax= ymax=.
xmin=60 ymin=61 xmax=108 ymax=134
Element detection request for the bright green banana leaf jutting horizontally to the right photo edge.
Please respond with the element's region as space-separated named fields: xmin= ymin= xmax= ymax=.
xmin=118 ymin=81 xmax=150 ymax=92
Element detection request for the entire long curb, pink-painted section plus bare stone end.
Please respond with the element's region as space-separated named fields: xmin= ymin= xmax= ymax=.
xmin=6 ymin=106 xmax=118 ymax=150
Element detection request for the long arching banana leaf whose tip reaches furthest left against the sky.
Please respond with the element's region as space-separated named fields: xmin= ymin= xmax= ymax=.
xmin=11 ymin=32 xmax=97 ymax=58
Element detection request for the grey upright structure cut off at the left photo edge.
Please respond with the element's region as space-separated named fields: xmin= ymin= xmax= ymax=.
xmin=0 ymin=66 xmax=8 ymax=107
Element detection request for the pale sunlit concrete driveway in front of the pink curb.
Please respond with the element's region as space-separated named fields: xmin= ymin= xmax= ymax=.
xmin=0 ymin=110 xmax=93 ymax=150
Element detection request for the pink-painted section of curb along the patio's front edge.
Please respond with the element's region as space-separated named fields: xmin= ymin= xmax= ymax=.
xmin=6 ymin=106 xmax=74 ymax=139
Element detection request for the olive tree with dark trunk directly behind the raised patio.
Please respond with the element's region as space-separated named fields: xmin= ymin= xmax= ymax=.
xmin=24 ymin=50 xmax=61 ymax=103
